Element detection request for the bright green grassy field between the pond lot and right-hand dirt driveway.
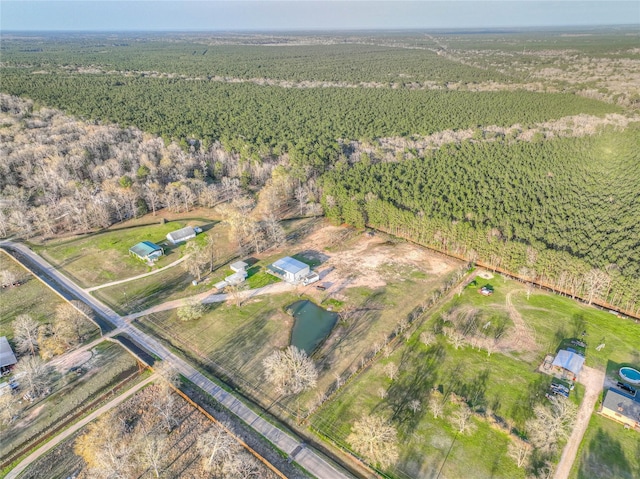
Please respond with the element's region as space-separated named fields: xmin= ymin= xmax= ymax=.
xmin=311 ymin=277 xmax=640 ymax=478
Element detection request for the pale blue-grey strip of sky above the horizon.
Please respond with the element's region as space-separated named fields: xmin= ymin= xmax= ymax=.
xmin=0 ymin=0 xmax=640 ymax=32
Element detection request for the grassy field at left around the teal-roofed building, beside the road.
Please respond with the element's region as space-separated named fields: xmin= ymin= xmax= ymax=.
xmin=37 ymin=218 xmax=210 ymax=287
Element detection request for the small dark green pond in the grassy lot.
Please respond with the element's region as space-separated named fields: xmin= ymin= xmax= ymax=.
xmin=287 ymin=300 xmax=338 ymax=355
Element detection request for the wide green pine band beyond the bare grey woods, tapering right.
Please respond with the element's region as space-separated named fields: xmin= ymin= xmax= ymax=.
xmin=2 ymin=70 xmax=620 ymax=163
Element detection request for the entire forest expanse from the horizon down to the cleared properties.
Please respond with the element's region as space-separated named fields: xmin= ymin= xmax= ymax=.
xmin=0 ymin=31 xmax=640 ymax=311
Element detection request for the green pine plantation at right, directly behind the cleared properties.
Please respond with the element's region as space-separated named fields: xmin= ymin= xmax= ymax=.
xmin=323 ymin=129 xmax=640 ymax=314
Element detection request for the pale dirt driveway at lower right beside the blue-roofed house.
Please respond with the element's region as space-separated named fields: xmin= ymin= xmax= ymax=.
xmin=553 ymin=366 xmax=605 ymax=479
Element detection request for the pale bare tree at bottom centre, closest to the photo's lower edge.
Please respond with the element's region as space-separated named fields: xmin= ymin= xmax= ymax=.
xmin=347 ymin=415 xmax=398 ymax=468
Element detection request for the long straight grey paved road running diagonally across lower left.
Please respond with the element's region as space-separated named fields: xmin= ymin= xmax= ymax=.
xmin=0 ymin=241 xmax=352 ymax=479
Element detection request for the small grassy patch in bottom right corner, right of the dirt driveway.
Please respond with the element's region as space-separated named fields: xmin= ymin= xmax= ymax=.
xmin=569 ymin=414 xmax=640 ymax=479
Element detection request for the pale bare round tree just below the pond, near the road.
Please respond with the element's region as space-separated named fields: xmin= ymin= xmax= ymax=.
xmin=262 ymin=346 xmax=318 ymax=395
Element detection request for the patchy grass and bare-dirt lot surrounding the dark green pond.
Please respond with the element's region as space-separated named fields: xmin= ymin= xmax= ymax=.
xmin=139 ymin=226 xmax=462 ymax=418
